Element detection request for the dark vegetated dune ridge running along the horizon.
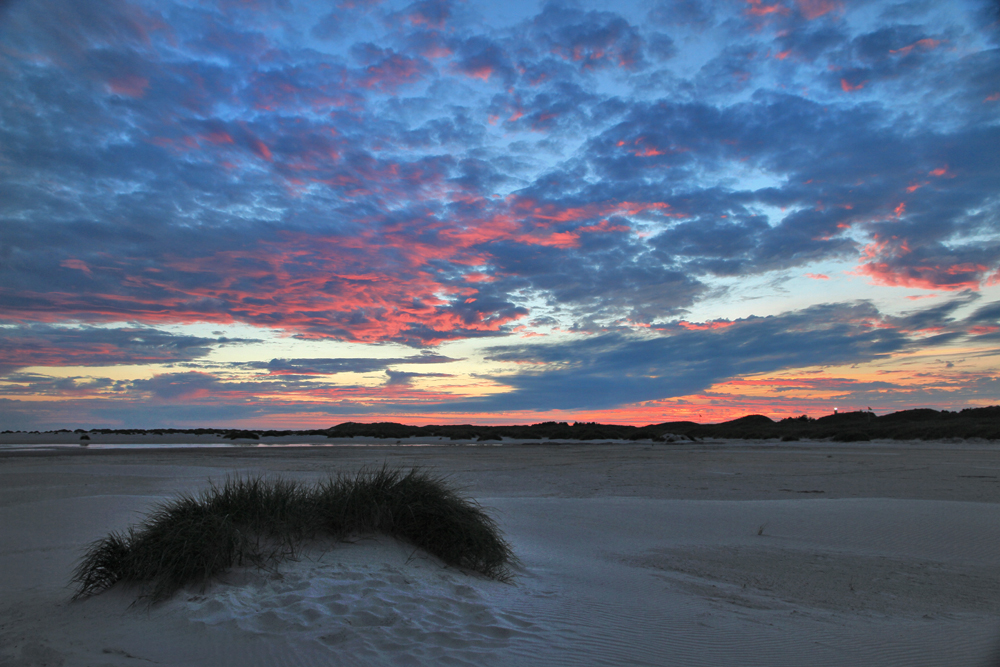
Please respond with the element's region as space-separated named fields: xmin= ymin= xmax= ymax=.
xmin=21 ymin=406 xmax=1000 ymax=442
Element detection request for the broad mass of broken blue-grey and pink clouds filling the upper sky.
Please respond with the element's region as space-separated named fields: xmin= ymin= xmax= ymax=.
xmin=0 ymin=3 xmax=1000 ymax=345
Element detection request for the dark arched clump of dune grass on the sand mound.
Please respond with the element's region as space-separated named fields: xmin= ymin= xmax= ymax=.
xmin=72 ymin=466 xmax=515 ymax=602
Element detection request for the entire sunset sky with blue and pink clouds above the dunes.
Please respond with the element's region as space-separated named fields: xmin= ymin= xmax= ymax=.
xmin=0 ymin=0 xmax=1000 ymax=430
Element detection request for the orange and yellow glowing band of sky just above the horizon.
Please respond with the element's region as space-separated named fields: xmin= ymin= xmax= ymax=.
xmin=0 ymin=332 xmax=1000 ymax=429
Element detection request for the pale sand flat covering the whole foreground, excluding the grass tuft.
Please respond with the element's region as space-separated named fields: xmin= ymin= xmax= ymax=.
xmin=0 ymin=443 xmax=1000 ymax=667
